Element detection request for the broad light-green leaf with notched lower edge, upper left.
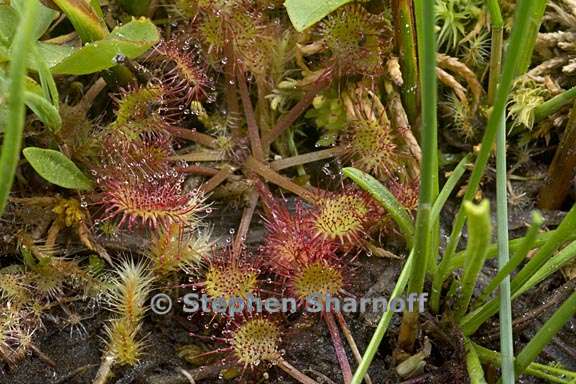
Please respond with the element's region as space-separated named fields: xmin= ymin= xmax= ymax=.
xmin=52 ymin=19 xmax=160 ymax=75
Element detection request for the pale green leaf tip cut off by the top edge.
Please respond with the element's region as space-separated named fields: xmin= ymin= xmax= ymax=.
xmin=284 ymin=0 xmax=352 ymax=32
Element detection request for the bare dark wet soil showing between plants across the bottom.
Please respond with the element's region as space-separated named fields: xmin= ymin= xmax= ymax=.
xmin=0 ymin=192 xmax=576 ymax=384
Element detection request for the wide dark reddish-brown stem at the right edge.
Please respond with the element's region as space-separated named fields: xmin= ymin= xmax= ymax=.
xmin=538 ymin=103 xmax=576 ymax=209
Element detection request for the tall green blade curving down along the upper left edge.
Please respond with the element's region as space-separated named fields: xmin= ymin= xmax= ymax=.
xmin=0 ymin=0 xmax=39 ymax=216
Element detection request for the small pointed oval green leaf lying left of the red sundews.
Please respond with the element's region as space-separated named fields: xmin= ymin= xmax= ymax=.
xmin=23 ymin=147 xmax=93 ymax=191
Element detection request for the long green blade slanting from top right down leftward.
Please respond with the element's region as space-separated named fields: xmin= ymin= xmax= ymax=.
xmin=430 ymin=0 xmax=547 ymax=311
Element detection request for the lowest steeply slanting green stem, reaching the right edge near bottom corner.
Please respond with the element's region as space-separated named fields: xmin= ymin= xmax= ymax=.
xmin=516 ymin=292 xmax=576 ymax=375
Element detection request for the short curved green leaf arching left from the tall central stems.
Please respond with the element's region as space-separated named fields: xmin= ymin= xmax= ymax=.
xmin=343 ymin=168 xmax=414 ymax=248
